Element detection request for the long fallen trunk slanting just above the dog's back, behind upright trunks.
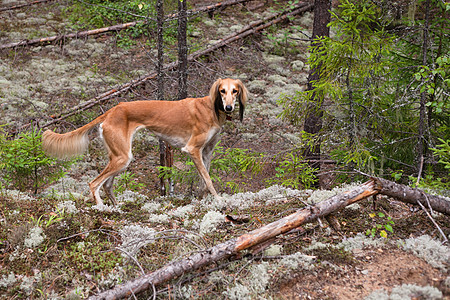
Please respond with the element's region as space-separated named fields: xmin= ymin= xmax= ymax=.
xmin=41 ymin=3 xmax=313 ymax=128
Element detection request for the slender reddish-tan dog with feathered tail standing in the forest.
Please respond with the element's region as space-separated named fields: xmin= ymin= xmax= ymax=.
xmin=42 ymin=78 xmax=248 ymax=204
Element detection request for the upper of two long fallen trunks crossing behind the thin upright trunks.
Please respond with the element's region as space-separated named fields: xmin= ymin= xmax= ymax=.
xmin=0 ymin=0 xmax=250 ymax=50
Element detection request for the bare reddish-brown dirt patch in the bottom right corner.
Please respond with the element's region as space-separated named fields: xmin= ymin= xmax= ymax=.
xmin=279 ymin=249 xmax=450 ymax=300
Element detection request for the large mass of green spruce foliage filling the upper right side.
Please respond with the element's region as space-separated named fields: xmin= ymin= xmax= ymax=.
xmin=280 ymin=0 xmax=450 ymax=188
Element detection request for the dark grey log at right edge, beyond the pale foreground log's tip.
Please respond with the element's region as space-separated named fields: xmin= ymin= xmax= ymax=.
xmin=373 ymin=178 xmax=450 ymax=216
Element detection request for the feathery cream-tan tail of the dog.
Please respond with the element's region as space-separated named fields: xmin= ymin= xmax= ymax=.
xmin=42 ymin=114 xmax=106 ymax=159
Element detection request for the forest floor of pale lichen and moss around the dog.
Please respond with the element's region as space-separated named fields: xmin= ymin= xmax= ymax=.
xmin=0 ymin=0 xmax=450 ymax=299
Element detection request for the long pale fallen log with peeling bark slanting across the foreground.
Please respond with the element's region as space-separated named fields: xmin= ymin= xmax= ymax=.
xmin=89 ymin=180 xmax=378 ymax=300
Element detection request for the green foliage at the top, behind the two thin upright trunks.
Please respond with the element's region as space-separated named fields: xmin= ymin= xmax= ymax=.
xmin=66 ymin=0 xmax=177 ymax=48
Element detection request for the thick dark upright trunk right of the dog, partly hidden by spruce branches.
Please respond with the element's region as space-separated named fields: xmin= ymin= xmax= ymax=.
xmin=304 ymin=0 xmax=331 ymax=186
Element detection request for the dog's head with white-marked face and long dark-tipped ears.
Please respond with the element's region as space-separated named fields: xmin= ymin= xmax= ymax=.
xmin=209 ymin=78 xmax=248 ymax=122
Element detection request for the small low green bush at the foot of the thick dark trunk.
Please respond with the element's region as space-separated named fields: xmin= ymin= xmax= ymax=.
xmin=267 ymin=151 xmax=318 ymax=189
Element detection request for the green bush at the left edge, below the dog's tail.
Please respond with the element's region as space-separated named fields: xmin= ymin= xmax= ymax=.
xmin=0 ymin=128 xmax=73 ymax=193
